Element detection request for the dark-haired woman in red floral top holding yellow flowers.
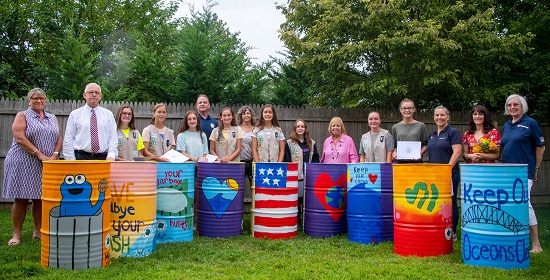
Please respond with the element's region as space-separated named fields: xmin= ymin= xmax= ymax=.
xmin=462 ymin=105 xmax=500 ymax=163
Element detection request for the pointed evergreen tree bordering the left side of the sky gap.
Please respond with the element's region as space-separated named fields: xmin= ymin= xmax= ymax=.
xmin=171 ymin=2 xmax=266 ymax=104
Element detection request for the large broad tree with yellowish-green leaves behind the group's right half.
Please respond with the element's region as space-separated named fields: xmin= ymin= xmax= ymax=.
xmin=279 ymin=0 xmax=530 ymax=110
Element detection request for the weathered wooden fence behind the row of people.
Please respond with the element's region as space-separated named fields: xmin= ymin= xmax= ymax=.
xmin=0 ymin=98 xmax=550 ymax=205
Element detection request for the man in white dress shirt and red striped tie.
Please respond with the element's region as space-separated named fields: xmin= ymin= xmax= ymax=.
xmin=63 ymin=83 xmax=118 ymax=160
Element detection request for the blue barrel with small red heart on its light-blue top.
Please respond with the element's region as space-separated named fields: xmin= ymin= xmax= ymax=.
xmin=348 ymin=163 xmax=393 ymax=244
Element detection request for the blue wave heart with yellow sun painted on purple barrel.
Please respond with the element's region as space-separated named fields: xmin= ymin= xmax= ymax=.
xmin=202 ymin=177 xmax=239 ymax=219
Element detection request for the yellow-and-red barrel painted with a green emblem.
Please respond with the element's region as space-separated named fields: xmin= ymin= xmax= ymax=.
xmin=393 ymin=164 xmax=453 ymax=257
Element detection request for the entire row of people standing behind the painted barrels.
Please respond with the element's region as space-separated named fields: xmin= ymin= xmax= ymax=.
xmin=2 ymin=83 xmax=545 ymax=252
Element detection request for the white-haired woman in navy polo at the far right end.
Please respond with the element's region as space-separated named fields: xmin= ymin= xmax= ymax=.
xmin=500 ymin=94 xmax=545 ymax=253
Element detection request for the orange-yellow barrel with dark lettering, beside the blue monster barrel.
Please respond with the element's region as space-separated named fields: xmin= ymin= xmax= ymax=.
xmin=111 ymin=161 xmax=157 ymax=258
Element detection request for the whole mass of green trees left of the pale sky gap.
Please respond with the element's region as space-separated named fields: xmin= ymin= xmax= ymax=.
xmin=0 ymin=0 xmax=268 ymax=104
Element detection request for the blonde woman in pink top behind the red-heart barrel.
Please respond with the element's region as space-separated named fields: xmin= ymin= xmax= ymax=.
xmin=321 ymin=117 xmax=359 ymax=163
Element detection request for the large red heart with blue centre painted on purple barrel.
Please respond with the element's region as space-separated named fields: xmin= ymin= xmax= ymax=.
xmin=313 ymin=173 xmax=347 ymax=222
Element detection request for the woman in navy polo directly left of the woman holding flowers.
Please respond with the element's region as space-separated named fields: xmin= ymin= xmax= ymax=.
xmin=427 ymin=106 xmax=462 ymax=240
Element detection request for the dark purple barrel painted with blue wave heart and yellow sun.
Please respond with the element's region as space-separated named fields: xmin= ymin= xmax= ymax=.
xmin=196 ymin=162 xmax=245 ymax=238
